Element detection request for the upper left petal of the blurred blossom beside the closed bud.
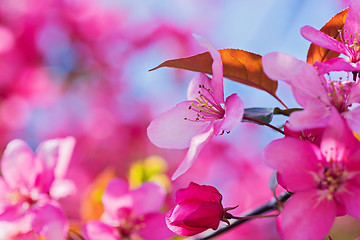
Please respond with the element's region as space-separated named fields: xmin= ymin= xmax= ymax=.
xmin=101 ymin=178 xmax=129 ymax=219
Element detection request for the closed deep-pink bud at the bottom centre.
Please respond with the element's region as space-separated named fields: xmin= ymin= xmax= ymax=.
xmin=166 ymin=182 xmax=225 ymax=236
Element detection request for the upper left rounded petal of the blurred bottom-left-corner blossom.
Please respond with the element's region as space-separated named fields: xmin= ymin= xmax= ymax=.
xmin=1 ymin=139 xmax=37 ymax=189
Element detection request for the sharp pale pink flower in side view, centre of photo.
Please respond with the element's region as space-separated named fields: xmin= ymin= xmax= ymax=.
xmin=147 ymin=36 xmax=244 ymax=180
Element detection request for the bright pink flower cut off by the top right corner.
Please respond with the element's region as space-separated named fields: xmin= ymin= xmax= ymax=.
xmin=301 ymin=0 xmax=360 ymax=74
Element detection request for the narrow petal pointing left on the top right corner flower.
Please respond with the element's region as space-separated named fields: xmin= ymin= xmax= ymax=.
xmin=300 ymin=25 xmax=348 ymax=55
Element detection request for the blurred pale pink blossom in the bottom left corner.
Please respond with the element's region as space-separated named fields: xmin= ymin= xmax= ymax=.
xmin=0 ymin=137 xmax=75 ymax=240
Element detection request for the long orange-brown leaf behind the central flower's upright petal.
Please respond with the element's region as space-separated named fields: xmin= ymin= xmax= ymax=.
xmin=150 ymin=49 xmax=281 ymax=102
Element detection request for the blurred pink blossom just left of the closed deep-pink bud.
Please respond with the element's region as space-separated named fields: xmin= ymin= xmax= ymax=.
xmin=82 ymin=179 xmax=173 ymax=240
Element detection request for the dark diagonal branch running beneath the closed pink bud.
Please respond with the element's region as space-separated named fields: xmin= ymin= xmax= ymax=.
xmin=188 ymin=192 xmax=291 ymax=240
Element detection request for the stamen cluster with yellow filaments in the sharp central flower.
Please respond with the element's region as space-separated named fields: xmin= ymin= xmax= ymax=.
xmin=184 ymin=85 xmax=225 ymax=122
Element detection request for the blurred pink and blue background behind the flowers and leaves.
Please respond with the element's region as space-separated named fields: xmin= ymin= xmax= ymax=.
xmin=0 ymin=0 xmax=360 ymax=240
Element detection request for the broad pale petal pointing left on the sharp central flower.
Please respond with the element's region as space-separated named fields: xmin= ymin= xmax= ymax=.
xmin=147 ymin=101 xmax=209 ymax=149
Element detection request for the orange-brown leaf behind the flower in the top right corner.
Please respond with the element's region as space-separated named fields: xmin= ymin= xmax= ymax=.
xmin=307 ymin=9 xmax=348 ymax=64
